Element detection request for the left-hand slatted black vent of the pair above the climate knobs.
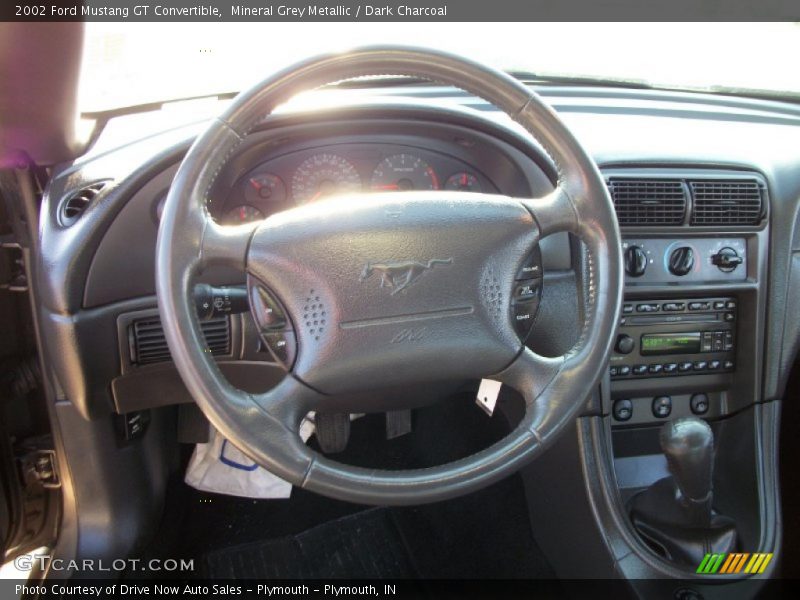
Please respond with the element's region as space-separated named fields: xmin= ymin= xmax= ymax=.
xmin=606 ymin=177 xmax=687 ymax=225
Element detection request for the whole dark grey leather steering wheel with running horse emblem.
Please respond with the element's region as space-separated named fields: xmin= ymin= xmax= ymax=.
xmin=156 ymin=47 xmax=622 ymax=505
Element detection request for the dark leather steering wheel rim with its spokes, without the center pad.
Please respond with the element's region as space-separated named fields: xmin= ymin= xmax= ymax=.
xmin=156 ymin=47 xmax=623 ymax=505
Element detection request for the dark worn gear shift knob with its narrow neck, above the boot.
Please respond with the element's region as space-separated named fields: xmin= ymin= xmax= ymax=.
xmin=660 ymin=417 xmax=714 ymax=516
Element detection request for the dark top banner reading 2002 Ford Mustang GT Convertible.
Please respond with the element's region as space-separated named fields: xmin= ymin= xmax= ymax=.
xmin=0 ymin=0 xmax=800 ymax=22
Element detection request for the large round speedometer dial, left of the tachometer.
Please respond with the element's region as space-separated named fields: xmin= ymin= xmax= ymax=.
xmin=292 ymin=153 xmax=361 ymax=204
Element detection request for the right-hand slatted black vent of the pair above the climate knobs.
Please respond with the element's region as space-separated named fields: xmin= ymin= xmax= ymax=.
xmin=689 ymin=179 xmax=764 ymax=225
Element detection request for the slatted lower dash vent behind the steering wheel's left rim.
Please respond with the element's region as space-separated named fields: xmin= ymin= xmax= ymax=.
xmin=129 ymin=316 xmax=231 ymax=365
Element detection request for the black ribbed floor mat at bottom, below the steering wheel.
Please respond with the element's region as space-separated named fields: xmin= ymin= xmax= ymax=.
xmin=203 ymin=509 xmax=417 ymax=579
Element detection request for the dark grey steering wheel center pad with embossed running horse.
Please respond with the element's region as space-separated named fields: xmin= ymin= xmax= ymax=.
xmin=247 ymin=192 xmax=538 ymax=394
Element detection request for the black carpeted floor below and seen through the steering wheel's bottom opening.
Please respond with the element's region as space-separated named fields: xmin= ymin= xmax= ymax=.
xmin=134 ymin=396 xmax=553 ymax=579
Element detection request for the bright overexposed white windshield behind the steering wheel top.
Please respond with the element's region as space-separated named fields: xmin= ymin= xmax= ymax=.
xmin=79 ymin=23 xmax=800 ymax=112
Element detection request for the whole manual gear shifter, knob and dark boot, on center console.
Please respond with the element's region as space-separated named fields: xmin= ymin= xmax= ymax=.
xmin=629 ymin=417 xmax=736 ymax=566
